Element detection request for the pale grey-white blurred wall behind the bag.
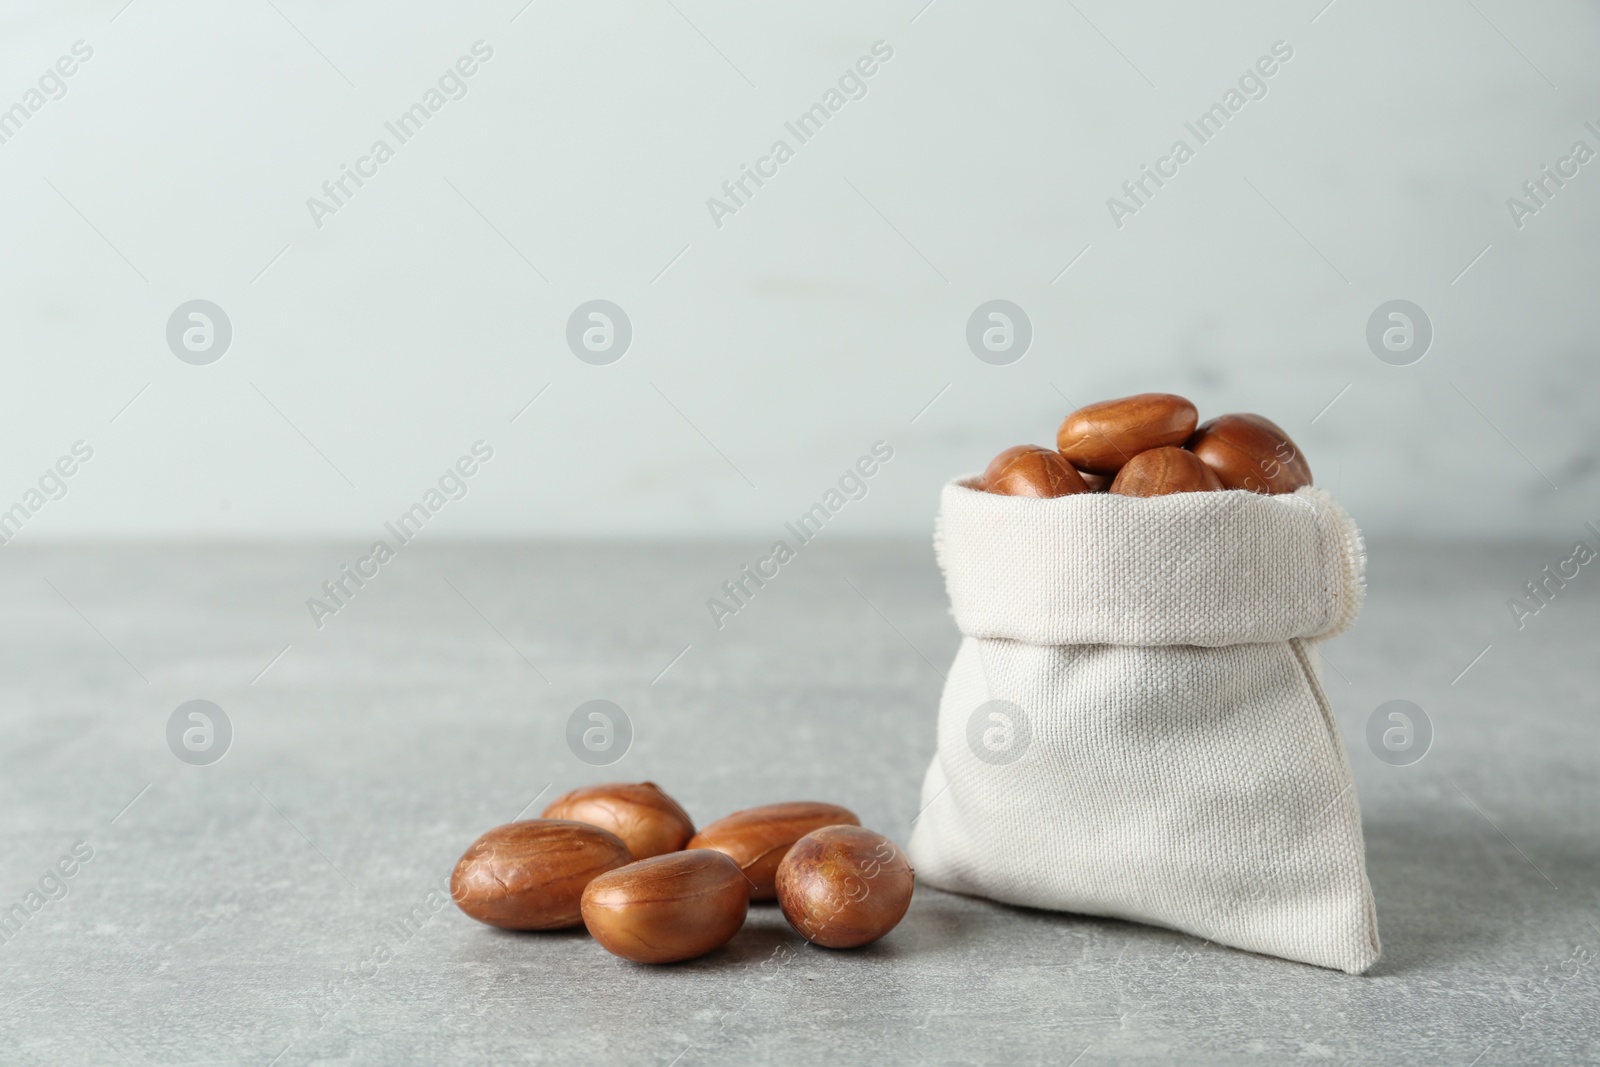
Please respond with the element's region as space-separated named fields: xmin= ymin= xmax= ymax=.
xmin=0 ymin=0 xmax=1600 ymax=542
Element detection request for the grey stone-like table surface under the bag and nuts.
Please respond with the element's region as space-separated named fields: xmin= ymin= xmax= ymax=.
xmin=0 ymin=541 xmax=1600 ymax=1067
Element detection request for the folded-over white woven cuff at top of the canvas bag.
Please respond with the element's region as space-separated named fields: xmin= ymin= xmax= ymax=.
xmin=934 ymin=480 xmax=1363 ymax=646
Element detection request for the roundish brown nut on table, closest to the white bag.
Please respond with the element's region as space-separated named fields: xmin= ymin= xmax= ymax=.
xmin=778 ymin=825 xmax=917 ymax=949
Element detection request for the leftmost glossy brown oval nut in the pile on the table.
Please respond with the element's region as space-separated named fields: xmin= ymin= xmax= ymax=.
xmin=450 ymin=819 xmax=634 ymax=929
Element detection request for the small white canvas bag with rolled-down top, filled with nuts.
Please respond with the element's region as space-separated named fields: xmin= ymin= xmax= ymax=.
xmin=909 ymin=478 xmax=1379 ymax=974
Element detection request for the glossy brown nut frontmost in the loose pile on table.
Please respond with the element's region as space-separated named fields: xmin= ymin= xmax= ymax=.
xmin=582 ymin=848 xmax=750 ymax=963
